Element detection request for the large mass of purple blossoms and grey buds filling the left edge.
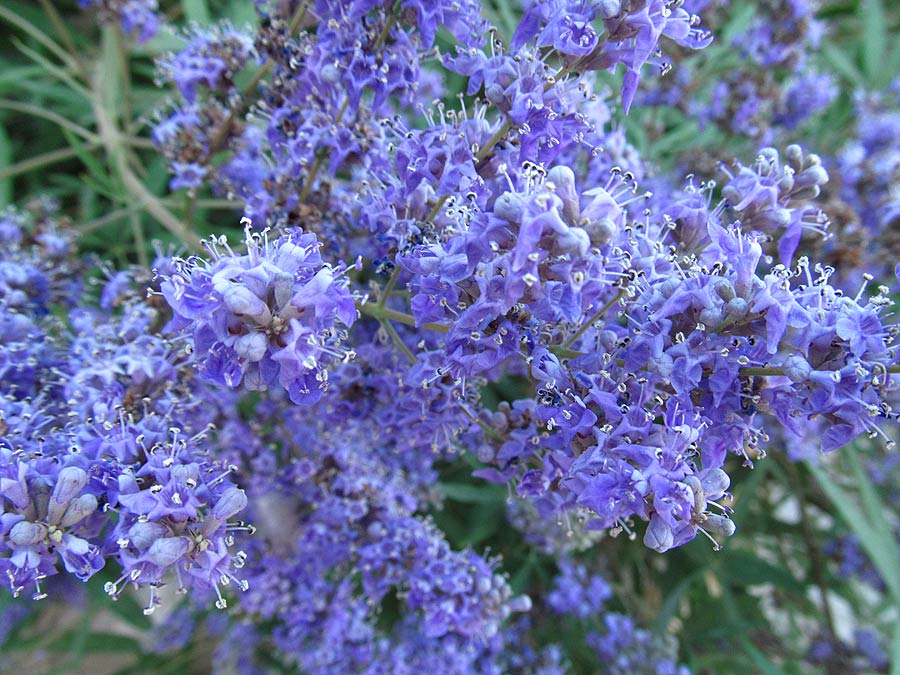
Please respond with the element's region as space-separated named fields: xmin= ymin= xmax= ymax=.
xmin=0 ymin=207 xmax=247 ymax=613
